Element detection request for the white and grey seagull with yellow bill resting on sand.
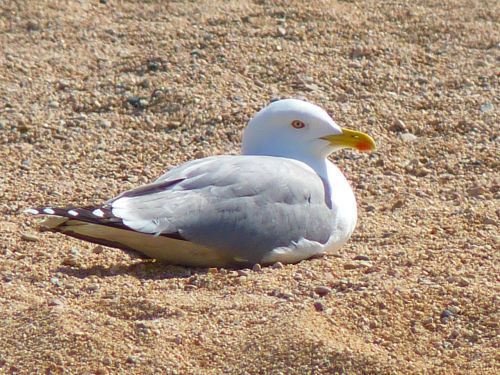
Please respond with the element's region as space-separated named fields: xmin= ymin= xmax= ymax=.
xmin=25 ymin=99 xmax=375 ymax=267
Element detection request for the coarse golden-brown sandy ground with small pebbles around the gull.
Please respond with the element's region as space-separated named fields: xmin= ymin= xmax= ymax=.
xmin=0 ymin=0 xmax=500 ymax=374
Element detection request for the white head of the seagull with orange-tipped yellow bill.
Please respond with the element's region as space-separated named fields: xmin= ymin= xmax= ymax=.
xmin=242 ymin=99 xmax=375 ymax=160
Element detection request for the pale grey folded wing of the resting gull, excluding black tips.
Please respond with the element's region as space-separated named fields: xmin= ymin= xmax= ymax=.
xmin=109 ymin=156 xmax=333 ymax=259
